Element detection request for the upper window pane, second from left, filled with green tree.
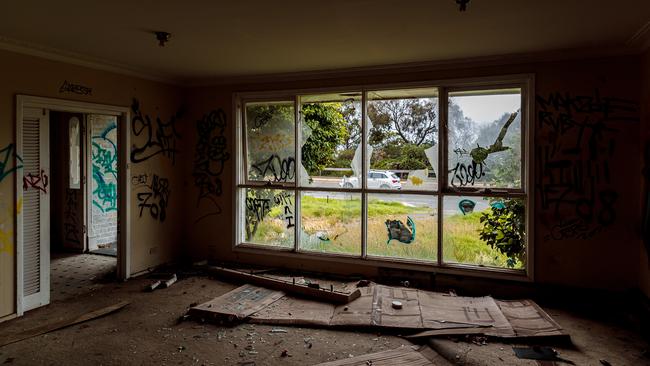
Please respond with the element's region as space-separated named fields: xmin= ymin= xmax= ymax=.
xmin=300 ymin=92 xmax=361 ymax=188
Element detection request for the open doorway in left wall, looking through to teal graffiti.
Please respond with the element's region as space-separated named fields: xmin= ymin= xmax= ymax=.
xmin=49 ymin=111 xmax=118 ymax=301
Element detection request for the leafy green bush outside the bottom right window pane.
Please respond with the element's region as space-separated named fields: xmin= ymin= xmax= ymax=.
xmin=479 ymin=198 xmax=526 ymax=267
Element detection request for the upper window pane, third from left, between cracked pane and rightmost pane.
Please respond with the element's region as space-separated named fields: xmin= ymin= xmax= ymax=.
xmin=367 ymin=88 xmax=438 ymax=190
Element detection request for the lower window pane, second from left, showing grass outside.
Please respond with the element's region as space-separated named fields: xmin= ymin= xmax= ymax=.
xmin=300 ymin=192 xmax=361 ymax=255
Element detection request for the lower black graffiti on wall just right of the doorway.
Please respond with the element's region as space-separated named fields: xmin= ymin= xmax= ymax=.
xmin=131 ymin=174 xmax=171 ymax=222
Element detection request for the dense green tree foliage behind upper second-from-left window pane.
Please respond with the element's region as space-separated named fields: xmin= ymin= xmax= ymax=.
xmin=302 ymin=103 xmax=349 ymax=175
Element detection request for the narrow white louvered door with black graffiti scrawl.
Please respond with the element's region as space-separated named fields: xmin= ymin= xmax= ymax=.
xmin=17 ymin=108 xmax=50 ymax=311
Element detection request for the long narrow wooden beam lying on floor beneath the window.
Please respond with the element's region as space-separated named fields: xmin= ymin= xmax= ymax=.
xmin=206 ymin=267 xmax=361 ymax=304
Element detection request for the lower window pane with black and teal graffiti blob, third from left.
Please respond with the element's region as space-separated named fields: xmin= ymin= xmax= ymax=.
xmin=368 ymin=194 xmax=438 ymax=261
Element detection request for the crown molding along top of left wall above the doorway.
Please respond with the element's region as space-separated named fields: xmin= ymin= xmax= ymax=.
xmin=0 ymin=35 xmax=183 ymax=86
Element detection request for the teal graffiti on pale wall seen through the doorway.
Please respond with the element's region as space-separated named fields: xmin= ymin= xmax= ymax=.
xmin=92 ymin=122 xmax=117 ymax=212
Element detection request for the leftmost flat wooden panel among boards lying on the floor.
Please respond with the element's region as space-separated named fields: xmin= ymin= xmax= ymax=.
xmin=189 ymin=285 xmax=285 ymax=320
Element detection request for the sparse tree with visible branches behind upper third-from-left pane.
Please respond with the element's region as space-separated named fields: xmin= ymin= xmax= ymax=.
xmin=368 ymin=98 xmax=438 ymax=146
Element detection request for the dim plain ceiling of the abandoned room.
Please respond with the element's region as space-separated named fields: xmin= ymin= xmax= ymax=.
xmin=0 ymin=0 xmax=650 ymax=82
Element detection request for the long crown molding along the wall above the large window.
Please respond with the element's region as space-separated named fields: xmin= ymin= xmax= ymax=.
xmin=184 ymin=43 xmax=650 ymax=87
